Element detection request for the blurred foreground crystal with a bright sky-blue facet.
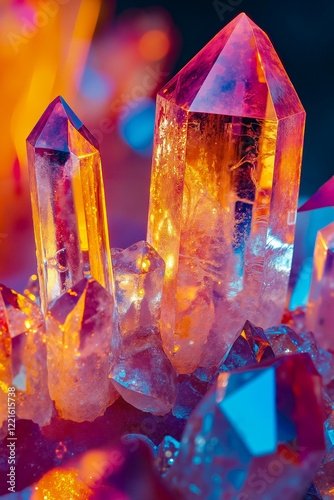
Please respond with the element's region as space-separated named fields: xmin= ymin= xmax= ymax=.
xmin=166 ymin=354 xmax=325 ymax=500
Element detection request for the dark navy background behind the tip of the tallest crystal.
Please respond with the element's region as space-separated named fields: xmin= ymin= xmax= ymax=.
xmin=116 ymin=0 xmax=334 ymax=196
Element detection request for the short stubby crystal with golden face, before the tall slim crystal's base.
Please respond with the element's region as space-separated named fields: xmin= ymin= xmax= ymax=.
xmin=47 ymin=277 xmax=117 ymax=422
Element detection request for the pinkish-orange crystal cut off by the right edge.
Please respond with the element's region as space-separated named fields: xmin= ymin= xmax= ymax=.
xmin=306 ymin=222 xmax=334 ymax=349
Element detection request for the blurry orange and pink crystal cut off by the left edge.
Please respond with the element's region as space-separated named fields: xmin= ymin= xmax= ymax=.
xmin=0 ymin=285 xmax=53 ymax=426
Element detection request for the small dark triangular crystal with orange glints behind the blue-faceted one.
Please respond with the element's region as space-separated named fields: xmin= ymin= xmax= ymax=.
xmin=218 ymin=321 xmax=275 ymax=373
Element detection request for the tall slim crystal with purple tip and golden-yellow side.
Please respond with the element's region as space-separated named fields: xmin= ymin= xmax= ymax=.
xmin=27 ymin=97 xmax=113 ymax=313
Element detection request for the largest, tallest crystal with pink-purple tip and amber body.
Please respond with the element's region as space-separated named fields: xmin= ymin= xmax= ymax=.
xmin=147 ymin=14 xmax=305 ymax=373
